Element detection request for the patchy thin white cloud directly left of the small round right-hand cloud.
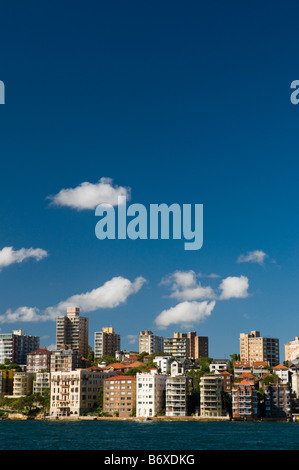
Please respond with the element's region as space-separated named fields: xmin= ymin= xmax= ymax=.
xmin=161 ymin=270 xmax=215 ymax=300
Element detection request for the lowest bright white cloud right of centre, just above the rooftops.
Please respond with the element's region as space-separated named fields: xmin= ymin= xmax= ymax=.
xmin=155 ymin=301 xmax=216 ymax=329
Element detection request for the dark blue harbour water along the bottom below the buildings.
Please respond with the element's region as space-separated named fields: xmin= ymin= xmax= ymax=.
xmin=0 ymin=420 xmax=299 ymax=450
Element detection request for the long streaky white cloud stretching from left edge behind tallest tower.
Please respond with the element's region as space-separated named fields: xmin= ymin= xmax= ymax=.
xmin=0 ymin=277 xmax=146 ymax=323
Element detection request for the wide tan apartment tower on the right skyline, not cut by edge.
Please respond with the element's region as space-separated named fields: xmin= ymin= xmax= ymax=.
xmin=240 ymin=331 xmax=279 ymax=367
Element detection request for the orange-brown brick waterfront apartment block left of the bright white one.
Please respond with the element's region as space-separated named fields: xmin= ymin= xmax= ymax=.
xmin=103 ymin=375 xmax=136 ymax=418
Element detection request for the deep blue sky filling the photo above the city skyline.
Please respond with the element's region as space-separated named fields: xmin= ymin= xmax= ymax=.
xmin=0 ymin=1 xmax=299 ymax=360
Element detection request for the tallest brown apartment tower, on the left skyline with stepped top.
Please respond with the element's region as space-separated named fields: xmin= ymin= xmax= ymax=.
xmin=56 ymin=307 xmax=88 ymax=358
